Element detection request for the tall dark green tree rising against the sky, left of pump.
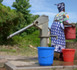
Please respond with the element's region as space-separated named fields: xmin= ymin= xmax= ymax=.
xmin=12 ymin=0 xmax=32 ymax=25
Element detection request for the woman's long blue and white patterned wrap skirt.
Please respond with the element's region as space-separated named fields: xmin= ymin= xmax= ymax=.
xmin=51 ymin=22 xmax=66 ymax=52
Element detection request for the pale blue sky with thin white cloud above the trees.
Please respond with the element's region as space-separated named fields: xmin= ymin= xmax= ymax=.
xmin=2 ymin=0 xmax=77 ymax=27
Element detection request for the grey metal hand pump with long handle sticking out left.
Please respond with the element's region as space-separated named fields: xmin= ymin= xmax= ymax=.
xmin=7 ymin=15 xmax=57 ymax=47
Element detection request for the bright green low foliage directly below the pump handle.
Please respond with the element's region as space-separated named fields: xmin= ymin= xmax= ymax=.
xmin=13 ymin=30 xmax=40 ymax=48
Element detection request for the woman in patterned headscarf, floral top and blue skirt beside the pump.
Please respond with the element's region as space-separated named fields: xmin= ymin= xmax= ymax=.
xmin=51 ymin=2 xmax=69 ymax=58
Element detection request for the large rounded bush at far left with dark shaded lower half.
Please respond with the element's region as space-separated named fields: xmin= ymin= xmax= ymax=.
xmin=0 ymin=4 xmax=25 ymax=44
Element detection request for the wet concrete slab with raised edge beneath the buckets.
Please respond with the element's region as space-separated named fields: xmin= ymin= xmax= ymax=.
xmin=5 ymin=60 xmax=77 ymax=70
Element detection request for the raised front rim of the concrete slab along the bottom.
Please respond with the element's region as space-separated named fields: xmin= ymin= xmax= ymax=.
xmin=5 ymin=63 xmax=77 ymax=70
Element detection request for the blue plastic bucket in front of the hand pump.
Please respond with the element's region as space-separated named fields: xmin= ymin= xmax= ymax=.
xmin=37 ymin=47 xmax=55 ymax=66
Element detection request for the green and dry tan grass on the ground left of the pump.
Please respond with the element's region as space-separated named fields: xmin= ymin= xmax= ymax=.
xmin=0 ymin=31 xmax=40 ymax=56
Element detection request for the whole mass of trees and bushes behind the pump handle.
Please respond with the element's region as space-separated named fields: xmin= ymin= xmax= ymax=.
xmin=0 ymin=0 xmax=39 ymax=44
